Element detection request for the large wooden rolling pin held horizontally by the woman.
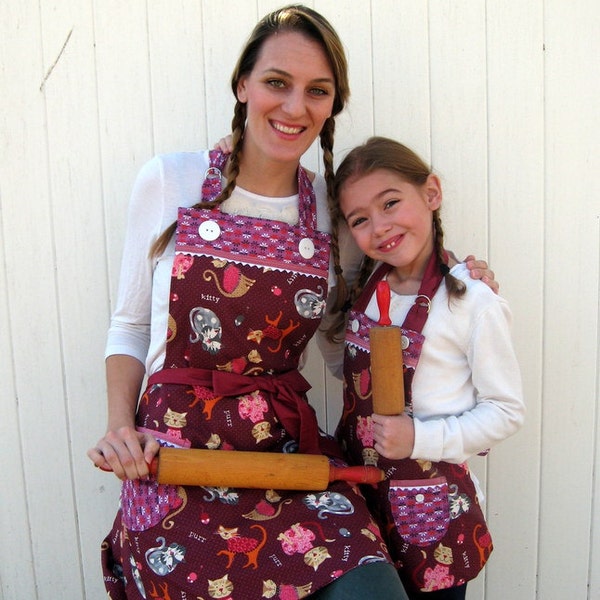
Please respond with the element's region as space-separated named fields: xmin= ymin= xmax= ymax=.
xmin=150 ymin=448 xmax=385 ymax=491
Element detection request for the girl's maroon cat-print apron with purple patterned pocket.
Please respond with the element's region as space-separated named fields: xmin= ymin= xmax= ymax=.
xmin=337 ymin=256 xmax=492 ymax=593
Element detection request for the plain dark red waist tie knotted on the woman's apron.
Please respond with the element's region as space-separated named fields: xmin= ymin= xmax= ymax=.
xmin=148 ymin=367 xmax=321 ymax=454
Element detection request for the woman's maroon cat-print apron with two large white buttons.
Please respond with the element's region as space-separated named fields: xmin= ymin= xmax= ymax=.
xmin=102 ymin=152 xmax=390 ymax=600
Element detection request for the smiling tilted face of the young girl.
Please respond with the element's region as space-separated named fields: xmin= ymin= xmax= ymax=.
xmin=339 ymin=169 xmax=442 ymax=280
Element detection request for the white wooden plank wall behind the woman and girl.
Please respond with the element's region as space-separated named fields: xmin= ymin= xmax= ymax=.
xmin=0 ymin=0 xmax=600 ymax=600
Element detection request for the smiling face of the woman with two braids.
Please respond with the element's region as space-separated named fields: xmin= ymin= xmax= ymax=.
xmin=237 ymin=32 xmax=335 ymax=162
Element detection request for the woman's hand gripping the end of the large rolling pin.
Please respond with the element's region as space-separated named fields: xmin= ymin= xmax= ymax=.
xmin=87 ymin=427 xmax=160 ymax=480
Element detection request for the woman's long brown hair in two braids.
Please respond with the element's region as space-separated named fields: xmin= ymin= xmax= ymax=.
xmin=150 ymin=4 xmax=350 ymax=262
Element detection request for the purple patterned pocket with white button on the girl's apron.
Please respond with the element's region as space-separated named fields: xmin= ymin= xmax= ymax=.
xmin=388 ymin=477 xmax=450 ymax=547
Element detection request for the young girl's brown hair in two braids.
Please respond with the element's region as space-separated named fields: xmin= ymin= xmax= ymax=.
xmin=327 ymin=136 xmax=466 ymax=341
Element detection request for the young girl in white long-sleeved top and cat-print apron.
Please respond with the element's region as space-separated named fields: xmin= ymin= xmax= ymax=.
xmin=329 ymin=138 xmax=525 ymax=599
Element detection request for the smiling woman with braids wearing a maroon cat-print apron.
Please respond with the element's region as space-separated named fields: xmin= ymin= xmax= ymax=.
xmin=88 ymin=6 xmax=405 ymax=599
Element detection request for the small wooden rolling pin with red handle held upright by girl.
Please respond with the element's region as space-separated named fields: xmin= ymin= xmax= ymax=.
xmin=369 ymin=280 xmax=404 ymax=415
